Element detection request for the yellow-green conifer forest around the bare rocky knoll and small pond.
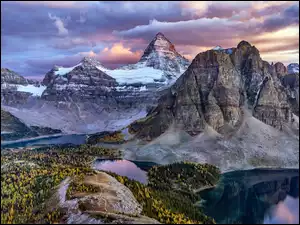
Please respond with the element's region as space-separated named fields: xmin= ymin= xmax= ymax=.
xmin=1 ymin=145 xmax=220 ymax=224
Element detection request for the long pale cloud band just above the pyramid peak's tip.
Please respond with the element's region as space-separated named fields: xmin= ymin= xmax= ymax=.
xmin=113 ymin=18 xmax=257 ymax=46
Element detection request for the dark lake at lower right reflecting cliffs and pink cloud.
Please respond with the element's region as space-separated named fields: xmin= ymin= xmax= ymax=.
xmin=200 ymin=169 xmax=299 ymax=224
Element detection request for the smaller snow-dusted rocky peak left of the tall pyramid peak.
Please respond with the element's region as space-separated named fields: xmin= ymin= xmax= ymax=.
xmin=42 ymin=57 xmax=117 ymax=101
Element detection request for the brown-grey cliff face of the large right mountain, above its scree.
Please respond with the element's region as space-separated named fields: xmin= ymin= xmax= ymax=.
xmin=131 ymin=41 xmax=298 ymax=140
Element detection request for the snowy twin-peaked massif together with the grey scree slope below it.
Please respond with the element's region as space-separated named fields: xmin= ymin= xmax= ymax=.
xmin=3 ymin=33 xmax=189 ymax=133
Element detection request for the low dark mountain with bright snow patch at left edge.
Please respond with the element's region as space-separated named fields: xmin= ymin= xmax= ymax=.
xmin=1 ymin=68 xmax=46 ymax=105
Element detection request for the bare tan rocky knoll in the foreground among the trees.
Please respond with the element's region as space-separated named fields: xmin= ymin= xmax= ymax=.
xmin=59 ymin=172 xmax=159 ymax=224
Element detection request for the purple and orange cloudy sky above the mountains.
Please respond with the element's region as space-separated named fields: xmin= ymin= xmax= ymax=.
xmin=1 ymin=1 xmax=299 ymax=79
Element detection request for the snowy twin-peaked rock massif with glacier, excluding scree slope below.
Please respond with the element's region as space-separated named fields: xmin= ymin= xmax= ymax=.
xmin=43 ymin=33 xmax=189 ymax=102
